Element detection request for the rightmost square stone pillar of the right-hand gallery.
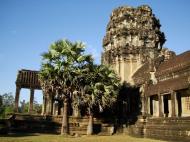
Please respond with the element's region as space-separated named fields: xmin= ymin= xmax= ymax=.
xmin=171 ymin=91 xmax=178 ymax=117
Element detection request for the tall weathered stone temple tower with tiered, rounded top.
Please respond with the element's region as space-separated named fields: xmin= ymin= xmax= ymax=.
xmin=102 ymin=5 xmax=165 ymax=85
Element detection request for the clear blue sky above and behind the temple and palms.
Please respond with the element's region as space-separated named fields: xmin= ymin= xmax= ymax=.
xmin=0 ymin=0 xmax=190 ymax=103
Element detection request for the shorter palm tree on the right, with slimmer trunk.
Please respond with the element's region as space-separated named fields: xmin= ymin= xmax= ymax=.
xmin=78 ymin=65 xmax=120 ymax=135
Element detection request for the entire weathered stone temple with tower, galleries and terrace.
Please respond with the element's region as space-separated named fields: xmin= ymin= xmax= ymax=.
xmin=11 ymin=5 xmax=190 ymax=141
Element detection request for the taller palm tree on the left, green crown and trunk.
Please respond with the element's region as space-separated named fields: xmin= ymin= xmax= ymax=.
xmin=40 ymin=40 xmax=93 ymax=134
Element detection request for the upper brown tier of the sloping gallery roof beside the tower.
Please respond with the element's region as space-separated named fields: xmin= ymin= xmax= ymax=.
xmin=132 ymin=51 xmax=190 ymax=85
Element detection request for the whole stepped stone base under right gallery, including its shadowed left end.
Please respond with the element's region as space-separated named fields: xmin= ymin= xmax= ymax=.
xmin=123 ymin=117 xmax=190 ymax=142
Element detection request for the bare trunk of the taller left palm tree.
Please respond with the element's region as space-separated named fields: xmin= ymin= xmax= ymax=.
xmin=61 ymin=99 xmax=69 ymax=135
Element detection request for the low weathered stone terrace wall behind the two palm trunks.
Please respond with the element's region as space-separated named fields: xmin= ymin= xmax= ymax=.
xmin=6 ymin=114 xmax=113 ymax=135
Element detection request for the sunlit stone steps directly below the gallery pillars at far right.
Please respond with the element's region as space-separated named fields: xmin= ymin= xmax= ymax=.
xmin=144 ymin=118 xmax=190 ymax=142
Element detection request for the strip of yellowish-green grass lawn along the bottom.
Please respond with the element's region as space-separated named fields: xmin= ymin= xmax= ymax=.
xmin=0 ymin=134 xmax=164 ymax=142
